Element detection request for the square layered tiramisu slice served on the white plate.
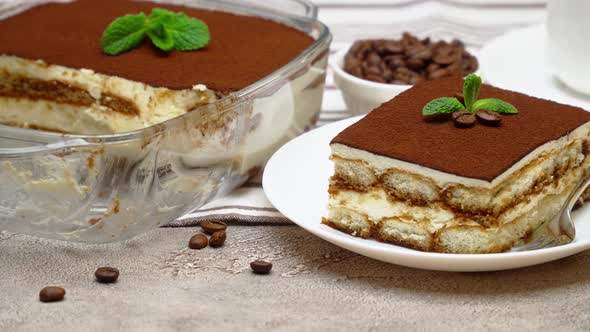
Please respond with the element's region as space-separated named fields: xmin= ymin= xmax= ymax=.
xmin=323 ymin=78 xmax=590 ymax=253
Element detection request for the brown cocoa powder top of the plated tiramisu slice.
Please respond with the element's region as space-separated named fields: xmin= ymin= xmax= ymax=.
xmin=332 ymin=78 xmax=590 ymax=181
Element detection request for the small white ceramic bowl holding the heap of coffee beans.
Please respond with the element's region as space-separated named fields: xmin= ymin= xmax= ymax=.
xmin=330 ymin=47 xmax=411 ymax=115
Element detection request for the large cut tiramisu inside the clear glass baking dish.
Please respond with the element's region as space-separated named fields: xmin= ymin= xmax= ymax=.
xmin=0 ymin=0 xmax=314 ymax=134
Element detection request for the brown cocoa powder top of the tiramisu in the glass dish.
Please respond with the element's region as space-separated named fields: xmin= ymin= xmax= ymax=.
xmin=0 ymin=0 xmax=314 ymax=93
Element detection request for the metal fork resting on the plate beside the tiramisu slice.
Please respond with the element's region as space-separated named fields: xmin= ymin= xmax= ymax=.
xmin=512 ymin=176 xmax=590 ymax=252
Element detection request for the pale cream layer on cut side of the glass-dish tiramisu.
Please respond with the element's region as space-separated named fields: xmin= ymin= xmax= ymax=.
xmin=0 ymin=55 xmax=216 ymax=134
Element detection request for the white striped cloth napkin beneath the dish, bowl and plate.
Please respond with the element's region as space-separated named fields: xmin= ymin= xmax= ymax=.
xmin=169 ymin=0 xmax=545 ymax=226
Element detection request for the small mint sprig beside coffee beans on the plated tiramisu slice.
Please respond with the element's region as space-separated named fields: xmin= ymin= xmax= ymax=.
xmin=422 ymin=74 xmax=518 ymax=117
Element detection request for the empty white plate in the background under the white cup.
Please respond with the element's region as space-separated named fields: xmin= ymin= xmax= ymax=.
xmin=478 ymin=25 xmax=590 ymax=110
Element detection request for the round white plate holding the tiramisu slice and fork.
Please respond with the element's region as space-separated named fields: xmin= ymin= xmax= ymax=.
xmin=263 ymin=117 xmax=590 ymax=272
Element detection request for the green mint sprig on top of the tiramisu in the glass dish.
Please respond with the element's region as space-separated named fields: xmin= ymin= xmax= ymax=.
xmin=101 ymin=8 xmax=211 ymax=55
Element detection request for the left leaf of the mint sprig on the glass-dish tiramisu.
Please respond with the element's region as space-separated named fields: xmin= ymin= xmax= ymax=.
xmin=101 ymin=13 xmax=147 ymax=55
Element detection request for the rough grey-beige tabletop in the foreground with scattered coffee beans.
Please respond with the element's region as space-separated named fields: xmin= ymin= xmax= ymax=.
xmin=0 ymin=226 xmax=590 ymax=331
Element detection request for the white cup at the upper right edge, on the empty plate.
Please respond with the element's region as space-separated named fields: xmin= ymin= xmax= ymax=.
xmin=548 ymin=0 xmax=590 ymax=94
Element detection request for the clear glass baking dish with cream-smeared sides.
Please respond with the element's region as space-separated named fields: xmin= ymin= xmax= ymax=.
xmin=0 ymin=0 xmax=331 ymax=243
